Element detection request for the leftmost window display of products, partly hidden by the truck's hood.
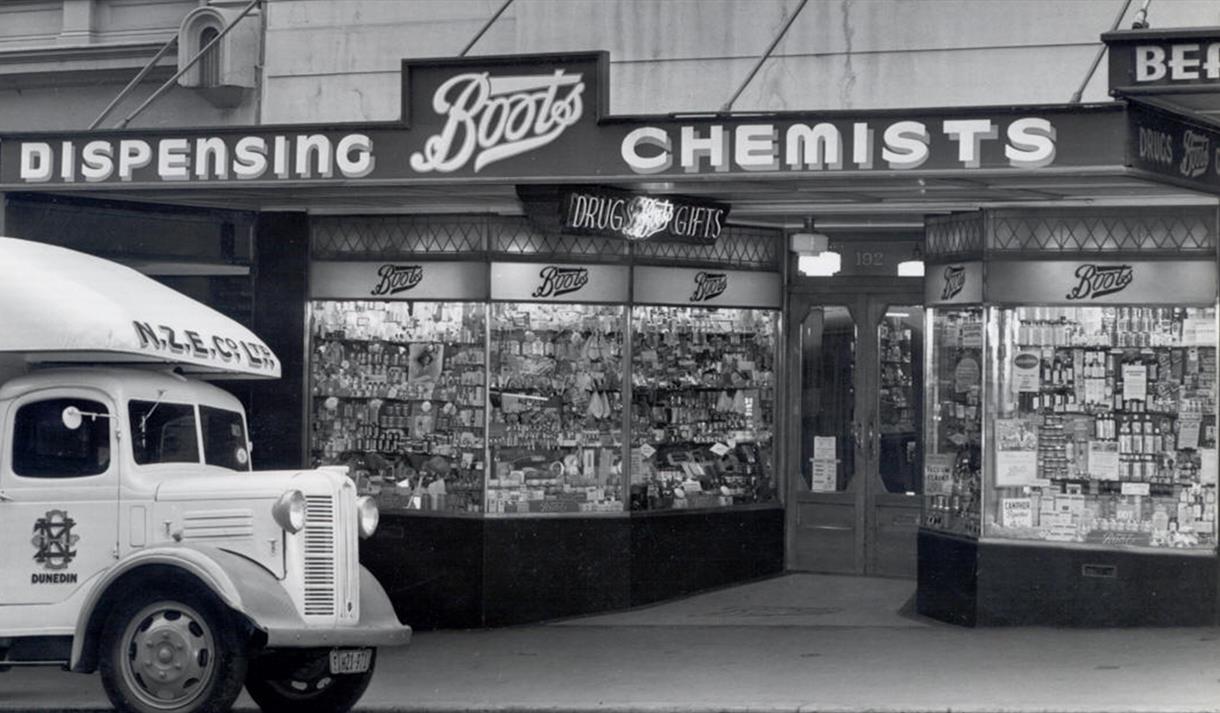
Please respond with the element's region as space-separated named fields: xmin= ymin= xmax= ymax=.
xmin=310 ymin=300 xmax=487 ymax=513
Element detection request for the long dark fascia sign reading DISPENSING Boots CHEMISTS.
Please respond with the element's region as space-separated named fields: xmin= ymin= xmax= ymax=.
xmin=0 ymin=52 xmax=1127 ymax=186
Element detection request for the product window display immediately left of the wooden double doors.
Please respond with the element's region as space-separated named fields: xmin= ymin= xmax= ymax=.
xmin=631 ymin=306 xmax=777 ymax=510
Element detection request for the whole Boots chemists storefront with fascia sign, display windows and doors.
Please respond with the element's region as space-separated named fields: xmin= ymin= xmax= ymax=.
xmin=0 ymin=34 xmax=1218 ymax=626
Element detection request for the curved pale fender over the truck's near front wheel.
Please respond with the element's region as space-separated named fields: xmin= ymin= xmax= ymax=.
xmin=70 ymin=545 xmax=287 ymax=671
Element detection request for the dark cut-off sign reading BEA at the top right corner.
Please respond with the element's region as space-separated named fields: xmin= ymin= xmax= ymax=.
xmin=1102 ymin=27 xmax=1220 ymax=94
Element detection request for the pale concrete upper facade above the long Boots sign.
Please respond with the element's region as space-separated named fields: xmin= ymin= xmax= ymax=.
xmin=7 ymin=0 xmax=1220 ymax=131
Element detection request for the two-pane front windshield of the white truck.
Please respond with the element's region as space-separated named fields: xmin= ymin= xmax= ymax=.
xmin=127 ymin=399 xmax=250 ymax=471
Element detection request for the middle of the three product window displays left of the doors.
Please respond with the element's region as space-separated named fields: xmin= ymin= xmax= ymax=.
xmin=487 ymin=303 xmax=625 ymax=513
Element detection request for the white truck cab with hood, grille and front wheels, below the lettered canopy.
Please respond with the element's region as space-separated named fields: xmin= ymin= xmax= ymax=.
xmin=0 ymin=238 xmax=411 ymax=713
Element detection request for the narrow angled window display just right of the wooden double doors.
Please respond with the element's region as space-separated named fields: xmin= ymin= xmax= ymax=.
xmin=924 ymin=308 xmax=983 ymax=536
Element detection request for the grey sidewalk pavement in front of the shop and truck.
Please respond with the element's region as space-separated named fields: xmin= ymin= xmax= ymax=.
xmin=0 ymin=574 xmax=1220 ymax=713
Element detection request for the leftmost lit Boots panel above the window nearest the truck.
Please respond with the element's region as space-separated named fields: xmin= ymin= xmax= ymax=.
xmin=309 ymin=261 xmax=489 ymax=302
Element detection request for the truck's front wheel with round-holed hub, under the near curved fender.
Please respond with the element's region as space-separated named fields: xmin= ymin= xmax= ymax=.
xmin=99 ymin=590 xmax=246 ymax=713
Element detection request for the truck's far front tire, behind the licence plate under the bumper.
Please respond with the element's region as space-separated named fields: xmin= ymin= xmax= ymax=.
xmin=245 ymin=650 xmax=377 ymax=713
